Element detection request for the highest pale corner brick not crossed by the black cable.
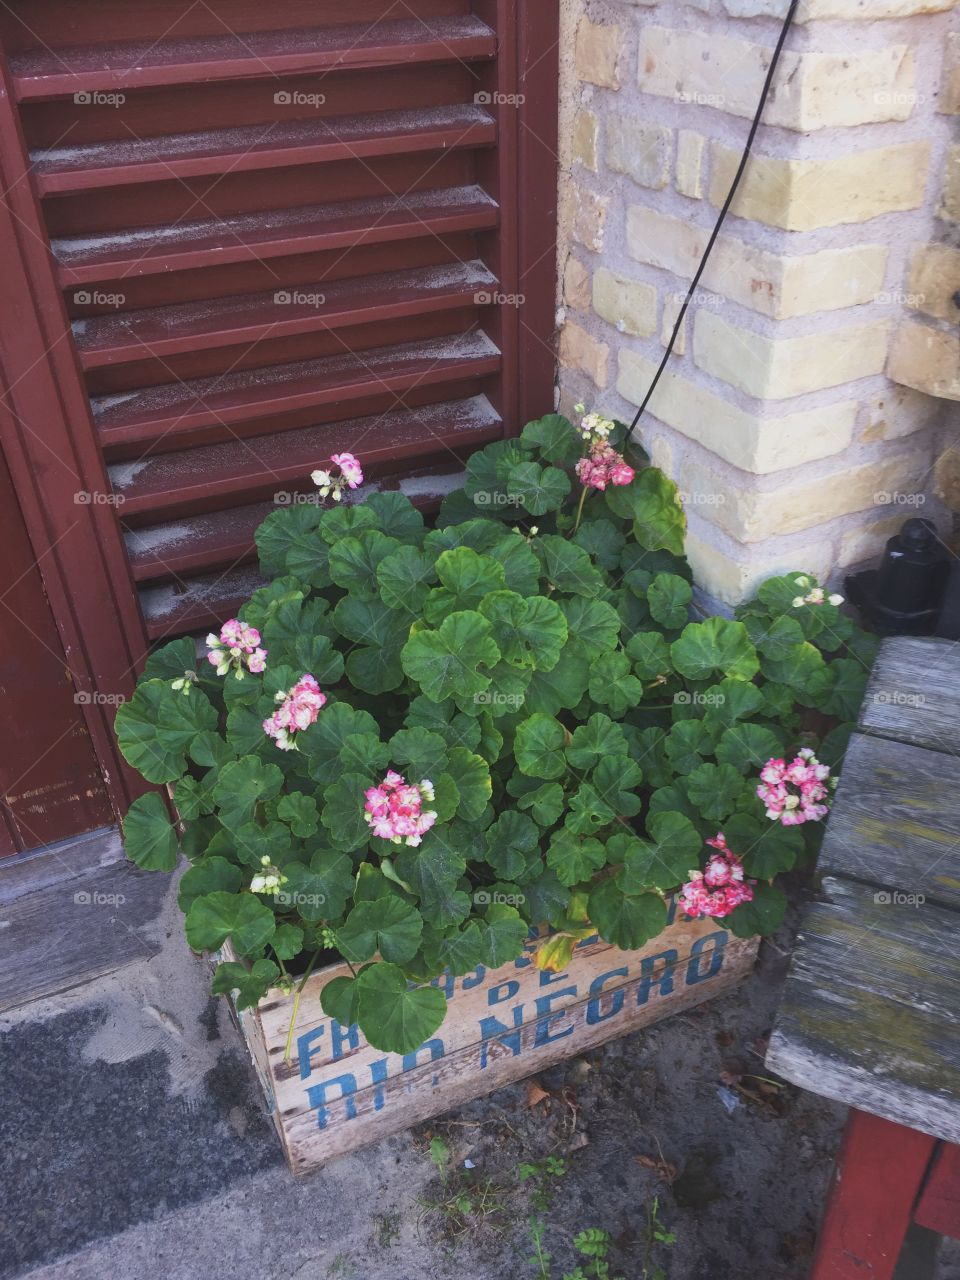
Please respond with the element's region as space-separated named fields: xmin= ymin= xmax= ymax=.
xmin=694 ymin=311 xmax=890 ymax=399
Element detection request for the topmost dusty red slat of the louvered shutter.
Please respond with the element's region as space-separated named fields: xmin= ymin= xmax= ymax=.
xmin=10 ymin=15 xmax=497 ymax=102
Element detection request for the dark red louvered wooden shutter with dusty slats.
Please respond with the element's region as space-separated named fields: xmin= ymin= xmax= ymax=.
xmin=0 ymin=0 xmax=557 ymax=639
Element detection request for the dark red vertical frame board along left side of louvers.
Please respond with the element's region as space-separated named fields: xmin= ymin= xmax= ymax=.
xmin=0 ymin=49 xmax=147 ymax=815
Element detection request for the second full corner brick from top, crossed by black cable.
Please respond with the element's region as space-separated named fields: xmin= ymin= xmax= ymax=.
xmin=710 ymin=142 xmax=931 ymax=232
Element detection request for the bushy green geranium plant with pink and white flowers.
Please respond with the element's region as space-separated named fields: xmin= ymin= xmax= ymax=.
xmin=116 ymin=415 xmax=870 ymax=1052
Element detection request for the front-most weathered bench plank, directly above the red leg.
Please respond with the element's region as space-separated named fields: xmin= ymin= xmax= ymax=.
xmin=767 ymin=878 xmax=960 ymax=1143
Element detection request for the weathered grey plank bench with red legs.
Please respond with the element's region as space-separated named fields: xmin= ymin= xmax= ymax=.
xmin=767 ymin=637 xmax=960 ymax=1280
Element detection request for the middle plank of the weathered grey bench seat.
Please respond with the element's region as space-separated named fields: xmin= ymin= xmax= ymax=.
xmin=819 ymin=733 xmax=960 ymax=910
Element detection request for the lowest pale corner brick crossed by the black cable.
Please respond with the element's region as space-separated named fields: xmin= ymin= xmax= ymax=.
xmin=617 ymin=349 xmax=858 ymax=475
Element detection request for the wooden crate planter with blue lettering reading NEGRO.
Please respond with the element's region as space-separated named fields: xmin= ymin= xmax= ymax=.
xmin=225 ymin=911 xmax=759 ymax=1174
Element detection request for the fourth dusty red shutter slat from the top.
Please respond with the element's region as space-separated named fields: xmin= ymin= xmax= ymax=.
xmin=73 ymin=260 xmax=497 ymax=369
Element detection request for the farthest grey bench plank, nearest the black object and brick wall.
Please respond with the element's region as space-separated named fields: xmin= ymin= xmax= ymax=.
xmin=860 ymin=636 xmax=960 ymax=754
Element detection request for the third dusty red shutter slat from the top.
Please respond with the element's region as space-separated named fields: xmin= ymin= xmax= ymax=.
xmin=51 ymin=186 xmax=499 ymax=287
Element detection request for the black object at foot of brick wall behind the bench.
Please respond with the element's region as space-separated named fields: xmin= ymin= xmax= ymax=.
xmin=846 ymin=516 xmax=960 ymax=635
